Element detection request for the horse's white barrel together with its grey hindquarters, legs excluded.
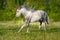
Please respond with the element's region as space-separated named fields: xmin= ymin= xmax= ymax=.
xmin=31 ymin=10 xmax=47 ymax=22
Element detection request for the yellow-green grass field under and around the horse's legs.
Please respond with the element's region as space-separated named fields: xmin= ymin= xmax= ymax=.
xmin=0 ymin=21 xmax=60 ymax=40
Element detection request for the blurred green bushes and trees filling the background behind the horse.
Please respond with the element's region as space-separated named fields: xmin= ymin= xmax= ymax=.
xmin=0 ymin=0 xmax=60 ymax=21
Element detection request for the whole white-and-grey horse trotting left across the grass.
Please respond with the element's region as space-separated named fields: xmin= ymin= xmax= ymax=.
xmin=16 ymin=5 xmax=48 ymax=33
